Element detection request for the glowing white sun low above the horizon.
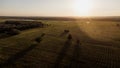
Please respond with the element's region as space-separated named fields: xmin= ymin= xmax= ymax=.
xmin=73 ymin=0 xmax=93 ymax=16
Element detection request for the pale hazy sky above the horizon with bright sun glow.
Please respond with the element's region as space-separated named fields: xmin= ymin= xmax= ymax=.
xmin=0 ymin=0 xmax=120 ymax=17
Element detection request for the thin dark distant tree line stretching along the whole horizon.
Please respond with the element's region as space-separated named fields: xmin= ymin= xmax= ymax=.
xmin=0 ymin=16 xmax=120 ymax=22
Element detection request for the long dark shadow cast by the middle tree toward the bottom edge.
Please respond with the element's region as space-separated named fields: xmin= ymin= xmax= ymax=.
xmin=54 ymin=39 xmax=72 ymax=68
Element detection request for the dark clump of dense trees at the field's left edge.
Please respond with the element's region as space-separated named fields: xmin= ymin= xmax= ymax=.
xmin=0 ymin=21 xmax=44 ymax=35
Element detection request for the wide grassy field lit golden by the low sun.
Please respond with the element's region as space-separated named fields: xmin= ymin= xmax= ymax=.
xmin=0 ymin=20 xmax=120 ymax=68
